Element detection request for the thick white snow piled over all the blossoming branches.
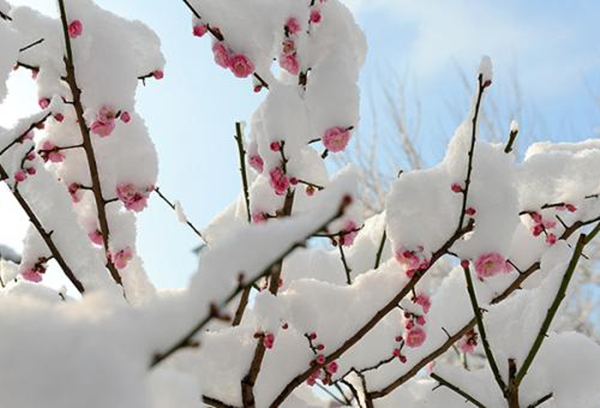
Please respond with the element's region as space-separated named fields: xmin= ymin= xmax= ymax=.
xmin=0 ymin=0 xmax=600 ymax=408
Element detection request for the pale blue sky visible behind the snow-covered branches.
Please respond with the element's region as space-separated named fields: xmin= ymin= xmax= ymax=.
xmin=0 ymin=0 xmax=600 ymax=287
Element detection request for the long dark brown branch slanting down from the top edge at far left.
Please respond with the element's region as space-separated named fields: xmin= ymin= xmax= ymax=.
xmin=58 ymin=0 xmax=123 ymax=286
